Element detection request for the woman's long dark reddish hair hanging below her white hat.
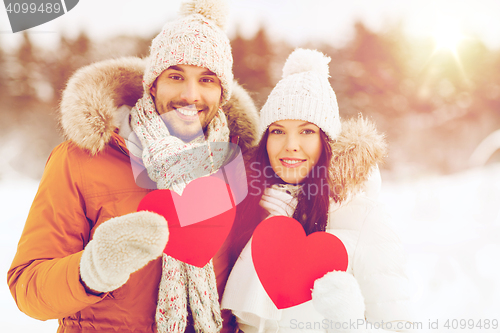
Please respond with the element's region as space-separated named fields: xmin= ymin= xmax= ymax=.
xmin=230 ymin=130 xmax=332 ymax=260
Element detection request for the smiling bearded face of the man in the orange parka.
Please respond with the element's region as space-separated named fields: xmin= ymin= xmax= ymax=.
xmin=151 ymin=65 xmax=222 ymax=142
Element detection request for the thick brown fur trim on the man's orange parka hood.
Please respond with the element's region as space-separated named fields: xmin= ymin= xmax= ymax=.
xmin=60 ymin=57 xmax=258 ymax=154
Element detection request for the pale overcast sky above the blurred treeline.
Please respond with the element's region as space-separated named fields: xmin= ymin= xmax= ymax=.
xmin=0 ymin=0 xmax=500 ymax=49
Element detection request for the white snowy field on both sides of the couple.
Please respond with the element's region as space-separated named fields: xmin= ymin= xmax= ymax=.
xmin=0 ymin=165 xmax=500 ymax=333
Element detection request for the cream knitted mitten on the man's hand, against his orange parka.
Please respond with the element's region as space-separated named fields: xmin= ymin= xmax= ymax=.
xmin=80 ymin=211 xmax=169 ymax=292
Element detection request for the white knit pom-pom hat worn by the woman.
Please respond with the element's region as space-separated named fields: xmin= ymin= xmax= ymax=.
xmin=260 ymin=49 xmax=341 ymax=140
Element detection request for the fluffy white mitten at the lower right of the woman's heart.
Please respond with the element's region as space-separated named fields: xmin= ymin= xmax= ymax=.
xmin=312 ymin=271 xmax=365 ymax=332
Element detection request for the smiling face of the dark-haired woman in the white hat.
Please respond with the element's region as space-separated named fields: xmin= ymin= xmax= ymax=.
xmin=266 ymin=120 xmax=323 ymax=184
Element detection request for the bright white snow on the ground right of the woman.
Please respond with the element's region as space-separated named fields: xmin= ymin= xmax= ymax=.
xmin=381 ymin=165 xmax=500 ymax=332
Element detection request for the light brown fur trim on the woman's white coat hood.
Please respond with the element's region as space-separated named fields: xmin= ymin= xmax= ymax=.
xmin=330 ymin=115 xmax=387 ymax=202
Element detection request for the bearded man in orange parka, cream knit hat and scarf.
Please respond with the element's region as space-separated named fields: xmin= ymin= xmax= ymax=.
xmin=8 ymin=0 xmax=257 ymax=332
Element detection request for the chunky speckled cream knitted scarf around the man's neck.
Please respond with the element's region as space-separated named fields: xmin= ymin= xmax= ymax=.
xmin=131 ymin=94 xmax=229 ymax=333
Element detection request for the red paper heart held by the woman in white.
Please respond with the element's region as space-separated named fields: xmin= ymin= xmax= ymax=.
xmin=252 ymin=216 xmax=348 ymax=309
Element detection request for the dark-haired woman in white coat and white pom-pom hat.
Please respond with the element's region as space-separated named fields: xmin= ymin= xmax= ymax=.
xmin=222 ymin=49 xmax=410 ymax=333
